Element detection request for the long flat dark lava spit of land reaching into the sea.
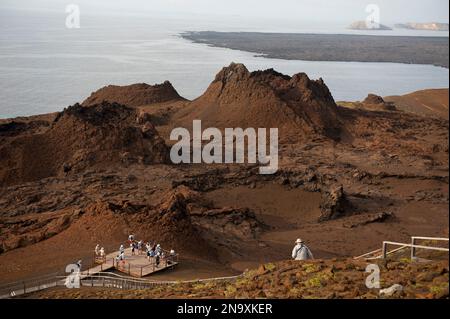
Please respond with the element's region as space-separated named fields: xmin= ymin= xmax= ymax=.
xmin=181 ymin=31 xmax=449 ymax=68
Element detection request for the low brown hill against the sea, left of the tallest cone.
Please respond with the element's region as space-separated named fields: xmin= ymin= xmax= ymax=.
xmin=82 ymin=81 xmax=184 ymax=107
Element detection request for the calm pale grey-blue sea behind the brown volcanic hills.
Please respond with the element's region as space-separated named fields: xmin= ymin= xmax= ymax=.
xmin=0 ymin=10 xmax=449 ymax=118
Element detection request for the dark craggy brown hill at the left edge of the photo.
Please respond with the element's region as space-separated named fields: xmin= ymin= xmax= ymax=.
xmin=0 ymin=102 xmax=168 ymax=185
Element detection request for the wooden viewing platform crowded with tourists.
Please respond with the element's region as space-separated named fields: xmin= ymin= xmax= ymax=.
xmin=81 ymin=248 xmax=178 ymax=279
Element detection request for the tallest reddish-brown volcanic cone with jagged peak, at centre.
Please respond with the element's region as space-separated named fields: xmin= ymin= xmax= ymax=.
xmin=174 ymin=63 xmax=341 ymax=140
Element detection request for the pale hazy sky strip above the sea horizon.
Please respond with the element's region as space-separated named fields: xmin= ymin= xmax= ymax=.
xmin=0 ymin=0 xmax=449 ymax=24
